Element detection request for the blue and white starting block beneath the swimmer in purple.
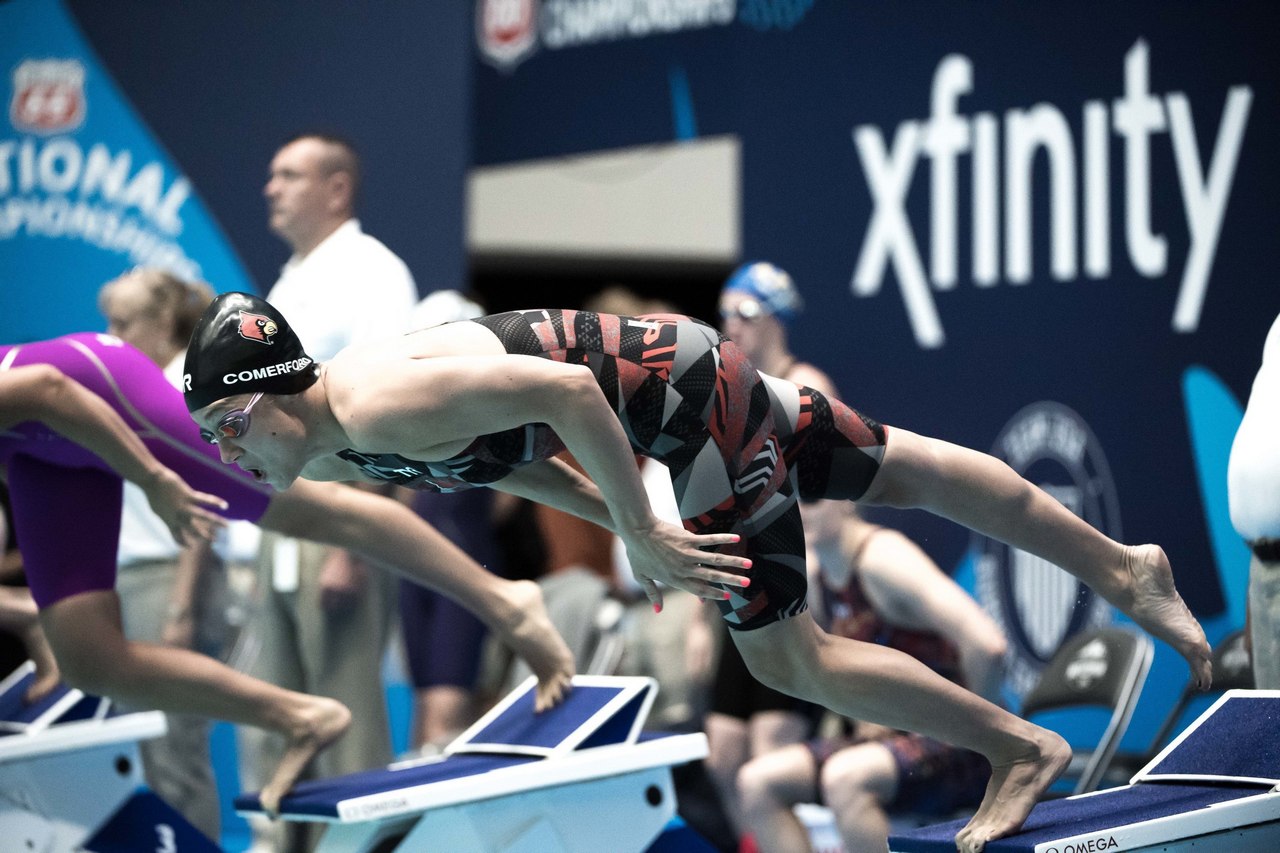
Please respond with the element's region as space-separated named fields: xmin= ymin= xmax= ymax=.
xmin=236 ymin=675 xmax=707 ymax=853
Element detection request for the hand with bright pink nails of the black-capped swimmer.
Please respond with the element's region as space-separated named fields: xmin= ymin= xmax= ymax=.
xmin=620 ymin=517 xmax=751 ymax=612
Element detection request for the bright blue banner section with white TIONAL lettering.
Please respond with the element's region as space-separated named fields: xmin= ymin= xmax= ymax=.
xmin=0 ymin=0 xmax=253 ymax=343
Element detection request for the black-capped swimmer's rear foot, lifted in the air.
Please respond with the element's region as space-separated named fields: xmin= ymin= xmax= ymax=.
xmin=1107 ymin=544 xmax=1213 ymax=690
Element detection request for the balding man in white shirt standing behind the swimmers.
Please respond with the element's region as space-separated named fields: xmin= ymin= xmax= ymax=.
xmin=241 ymin=134 xmax=417 ymax=849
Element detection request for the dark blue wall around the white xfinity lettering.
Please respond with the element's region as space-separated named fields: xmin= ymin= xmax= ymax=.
xmin=475 ymin=0 xmax=1280 ymax=706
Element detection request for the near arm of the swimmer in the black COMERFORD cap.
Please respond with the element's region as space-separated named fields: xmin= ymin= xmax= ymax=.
xmin=328 ymin=355 xmax=750 ymax=607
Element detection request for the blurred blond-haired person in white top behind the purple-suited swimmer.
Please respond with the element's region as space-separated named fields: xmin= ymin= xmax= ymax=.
xmin=99 ymin=268 xmax=227 ymax=840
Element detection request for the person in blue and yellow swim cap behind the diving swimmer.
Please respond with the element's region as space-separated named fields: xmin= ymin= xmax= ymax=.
xmin=703 ymin=261 xmax=838 ymax=831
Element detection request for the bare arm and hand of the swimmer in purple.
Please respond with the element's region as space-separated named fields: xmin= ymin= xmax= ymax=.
xmin=0 ymin=364 xmax=227 ymax=542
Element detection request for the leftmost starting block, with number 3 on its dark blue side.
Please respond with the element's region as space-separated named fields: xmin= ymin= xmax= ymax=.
xmin=0 ymin=661 xmax=216 ymax=853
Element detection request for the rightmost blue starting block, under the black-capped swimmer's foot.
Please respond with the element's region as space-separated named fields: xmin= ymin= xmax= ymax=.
xmin=890 ymin=690 xmax=1280 ymax=853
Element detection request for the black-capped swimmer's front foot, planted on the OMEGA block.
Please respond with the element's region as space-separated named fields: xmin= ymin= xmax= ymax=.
xmin=956 ymin=726 xmax=1071 ymax=853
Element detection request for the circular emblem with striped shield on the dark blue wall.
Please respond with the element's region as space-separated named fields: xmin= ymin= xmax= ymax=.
xmin=972 ymin=402 xmax=1123 ymax=695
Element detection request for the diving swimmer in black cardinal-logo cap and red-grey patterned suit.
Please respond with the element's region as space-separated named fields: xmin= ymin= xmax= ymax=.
xmin=184 ymin=293 xmax=1211 ymax=850
